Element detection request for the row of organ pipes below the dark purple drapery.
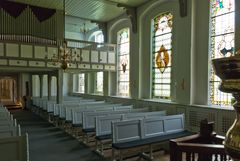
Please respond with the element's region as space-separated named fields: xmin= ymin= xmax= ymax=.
xmin=0 ymin=6 xmax=64 ymax=45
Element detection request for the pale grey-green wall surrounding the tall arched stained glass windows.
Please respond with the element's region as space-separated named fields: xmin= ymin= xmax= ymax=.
xmin=78 ymin=0 xmax=240 ymax=112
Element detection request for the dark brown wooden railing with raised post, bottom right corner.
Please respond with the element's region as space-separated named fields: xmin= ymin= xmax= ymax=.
xmin=170 ymin=120 xmax=231 ymax=161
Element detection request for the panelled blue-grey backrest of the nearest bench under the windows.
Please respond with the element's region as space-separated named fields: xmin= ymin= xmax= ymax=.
xmin=112 ymin=115 xmax=184 ymax=143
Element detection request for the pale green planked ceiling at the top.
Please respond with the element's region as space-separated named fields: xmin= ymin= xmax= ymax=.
xmin=11 ymin=0 xmax=150 ymax=22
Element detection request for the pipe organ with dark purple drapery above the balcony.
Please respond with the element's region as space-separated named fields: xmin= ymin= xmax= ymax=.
xmin=0 ymin=1 xmax=64 ymax=45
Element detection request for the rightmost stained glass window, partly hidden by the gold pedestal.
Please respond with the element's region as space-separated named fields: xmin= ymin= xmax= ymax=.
xmin=209 ymin=0 xmax=235 ymax=106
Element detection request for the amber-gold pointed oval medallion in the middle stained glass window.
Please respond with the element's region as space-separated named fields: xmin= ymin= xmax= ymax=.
xmin=156 ymin=45 xmax=169 ymax=73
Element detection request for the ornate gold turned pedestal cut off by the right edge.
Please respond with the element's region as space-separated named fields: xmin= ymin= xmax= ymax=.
xmin=212 ymin=55 xmax=240 ymax=161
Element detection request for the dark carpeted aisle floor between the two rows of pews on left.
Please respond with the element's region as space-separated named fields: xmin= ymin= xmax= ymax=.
xmin=11 ymin=110 xmax=105 ymax=161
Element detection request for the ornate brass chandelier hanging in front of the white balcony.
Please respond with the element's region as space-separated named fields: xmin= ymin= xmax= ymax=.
xmin=50 ymin=41 xmax=80 ymax=70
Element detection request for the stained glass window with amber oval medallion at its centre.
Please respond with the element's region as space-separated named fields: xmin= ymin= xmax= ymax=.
xmin=152 ymin=12 xmax=173 ymax=99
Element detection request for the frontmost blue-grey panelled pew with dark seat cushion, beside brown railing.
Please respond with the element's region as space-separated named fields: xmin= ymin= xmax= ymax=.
xmin=112 ymin=115 xmax=192 ymax=161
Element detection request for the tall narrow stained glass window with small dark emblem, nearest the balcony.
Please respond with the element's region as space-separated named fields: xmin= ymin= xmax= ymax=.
xmin=117 ymin=28 xmax=130 ymax=96
